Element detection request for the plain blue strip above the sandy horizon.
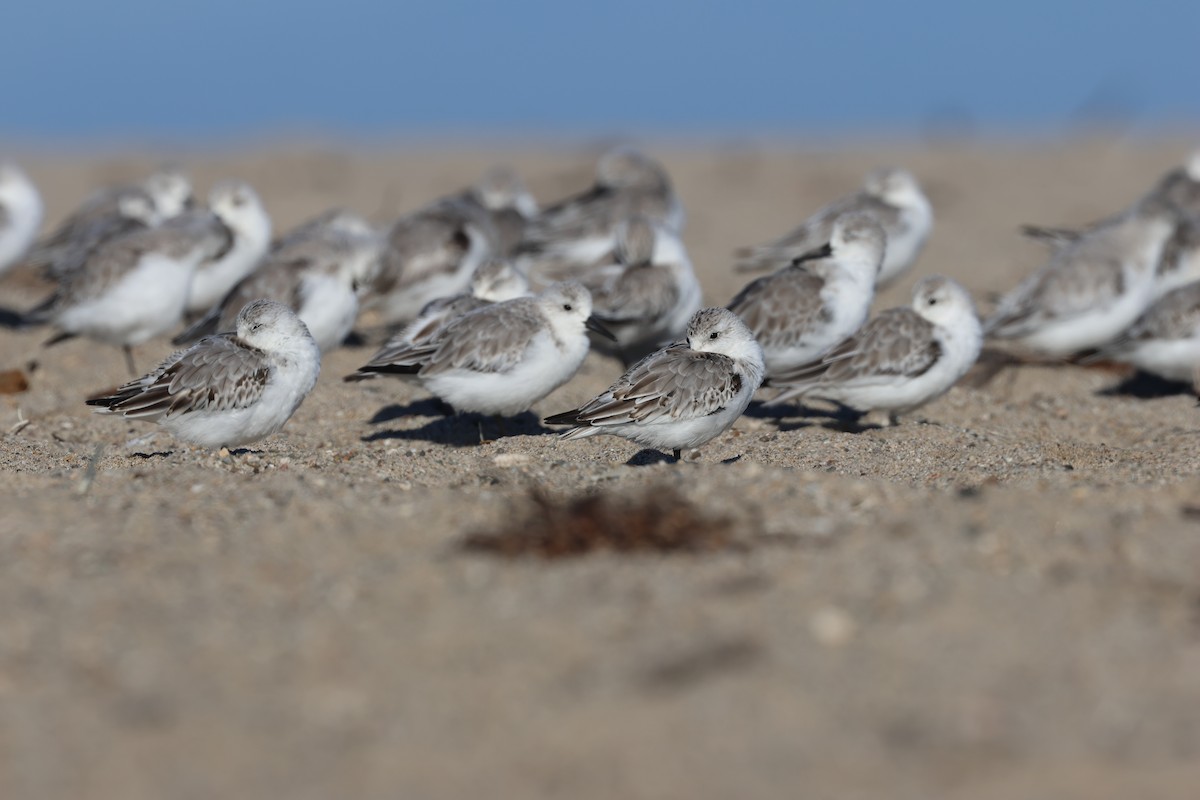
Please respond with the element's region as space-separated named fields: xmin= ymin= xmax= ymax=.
xmin=0 ymin=0 xmax=1200 ymax=142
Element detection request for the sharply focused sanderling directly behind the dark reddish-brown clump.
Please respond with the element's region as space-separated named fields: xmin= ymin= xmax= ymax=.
xmin=546 ymin=308 xmax=764 ymax=461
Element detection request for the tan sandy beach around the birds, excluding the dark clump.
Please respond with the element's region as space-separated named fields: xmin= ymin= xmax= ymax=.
xmin=0 ymin=138 xmax=1200 ymax=800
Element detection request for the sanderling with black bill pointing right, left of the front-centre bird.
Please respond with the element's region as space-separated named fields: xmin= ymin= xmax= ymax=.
xmin=346 ymin=282 xmax=604 ymax=416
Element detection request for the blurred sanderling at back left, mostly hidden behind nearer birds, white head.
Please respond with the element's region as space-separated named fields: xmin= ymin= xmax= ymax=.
xmin=32 ymin=169 xmax=192 ymax=281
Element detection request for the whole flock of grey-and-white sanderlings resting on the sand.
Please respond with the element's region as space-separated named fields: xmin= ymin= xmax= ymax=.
xmin=0 ymin=149 xmax=1200 ymax=459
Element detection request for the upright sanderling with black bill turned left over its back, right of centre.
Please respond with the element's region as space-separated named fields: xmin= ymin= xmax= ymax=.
xmin=728 ymin=212 xmax=886 ymax=378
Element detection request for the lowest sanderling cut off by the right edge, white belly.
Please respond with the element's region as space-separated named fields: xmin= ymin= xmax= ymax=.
xmin=1096 ymin=282 xmax=1200 ymax=391
